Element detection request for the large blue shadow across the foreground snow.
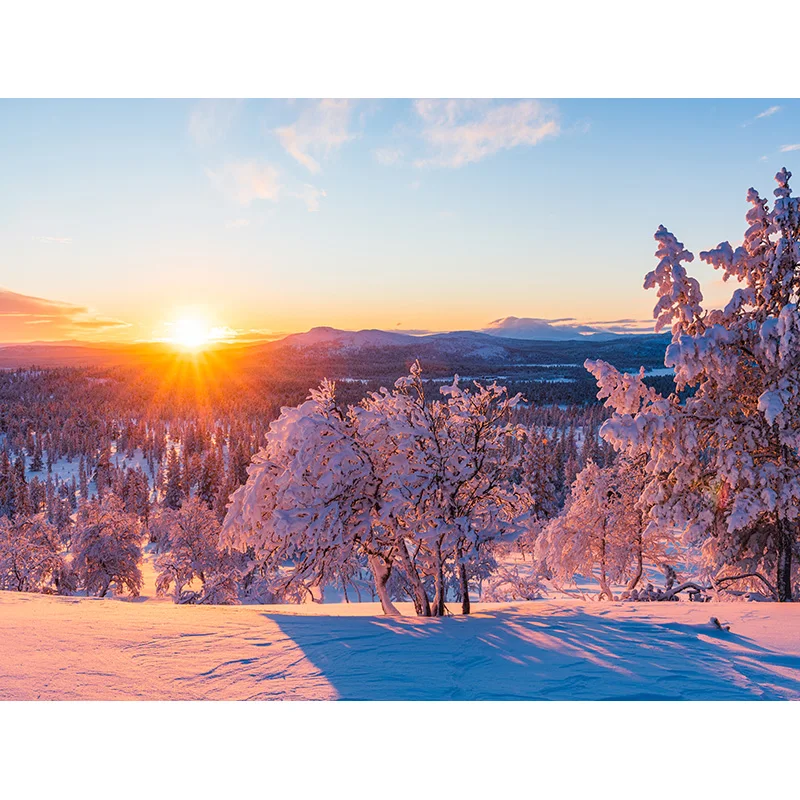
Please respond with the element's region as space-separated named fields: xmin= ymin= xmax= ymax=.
xmin=265 ymin=609 xmax=800 ymax=700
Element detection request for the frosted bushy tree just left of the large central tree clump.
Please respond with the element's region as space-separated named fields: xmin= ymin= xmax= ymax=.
xmin=154 ymin=496 xmax=238 ymax=604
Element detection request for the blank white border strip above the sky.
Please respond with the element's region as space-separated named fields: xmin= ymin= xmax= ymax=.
xmin=0 ymin=0 xmax=800 ymax=97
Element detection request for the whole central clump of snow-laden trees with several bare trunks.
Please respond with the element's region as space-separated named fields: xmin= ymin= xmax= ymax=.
xmin=222 ymin=364 xmax=532 ymax=615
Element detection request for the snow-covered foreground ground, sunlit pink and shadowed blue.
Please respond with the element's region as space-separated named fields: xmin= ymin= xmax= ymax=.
xmin=0 ymin=592 xmax=800 ymax=700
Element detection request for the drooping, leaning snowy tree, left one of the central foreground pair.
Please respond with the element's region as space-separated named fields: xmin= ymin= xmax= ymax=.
xmin=222 ymin=381 xmax=404 ymax=614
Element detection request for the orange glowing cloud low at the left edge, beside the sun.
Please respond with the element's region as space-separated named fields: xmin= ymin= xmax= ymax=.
xmin=0 ymin=289 xmax=130 ymax=342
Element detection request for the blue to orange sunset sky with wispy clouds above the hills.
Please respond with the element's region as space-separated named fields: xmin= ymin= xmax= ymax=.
xmin=0 ymin=99 xmax=800 ymax=342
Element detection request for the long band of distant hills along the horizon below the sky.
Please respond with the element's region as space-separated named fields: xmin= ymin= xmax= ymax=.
xmin=0 ymin=327 xmax=669 ymax=377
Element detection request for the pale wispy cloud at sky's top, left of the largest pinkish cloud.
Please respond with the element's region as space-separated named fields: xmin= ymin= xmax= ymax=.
xmin=275 ymin=100 xmax=355 ymax=173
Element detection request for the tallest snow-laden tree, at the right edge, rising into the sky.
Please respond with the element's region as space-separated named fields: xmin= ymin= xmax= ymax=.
xmin=586 ymin=169 xmax=800 ymax=600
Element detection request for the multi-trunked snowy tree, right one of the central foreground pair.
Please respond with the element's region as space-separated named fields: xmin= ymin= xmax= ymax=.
xmin=359 ymin=363 xmax=532 ymax=616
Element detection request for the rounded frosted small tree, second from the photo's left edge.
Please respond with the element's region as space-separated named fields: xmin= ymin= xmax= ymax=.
xmin=72 ymin=494 xmax=142 ymax=597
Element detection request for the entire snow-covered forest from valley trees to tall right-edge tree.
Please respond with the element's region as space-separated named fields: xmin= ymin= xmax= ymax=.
xmin=0 ymin=170 xmax=800 ymax=616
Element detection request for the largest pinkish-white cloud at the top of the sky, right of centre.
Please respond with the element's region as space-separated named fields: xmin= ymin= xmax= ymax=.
xmin=414 ymin=100 xmax=560 ymax=167
